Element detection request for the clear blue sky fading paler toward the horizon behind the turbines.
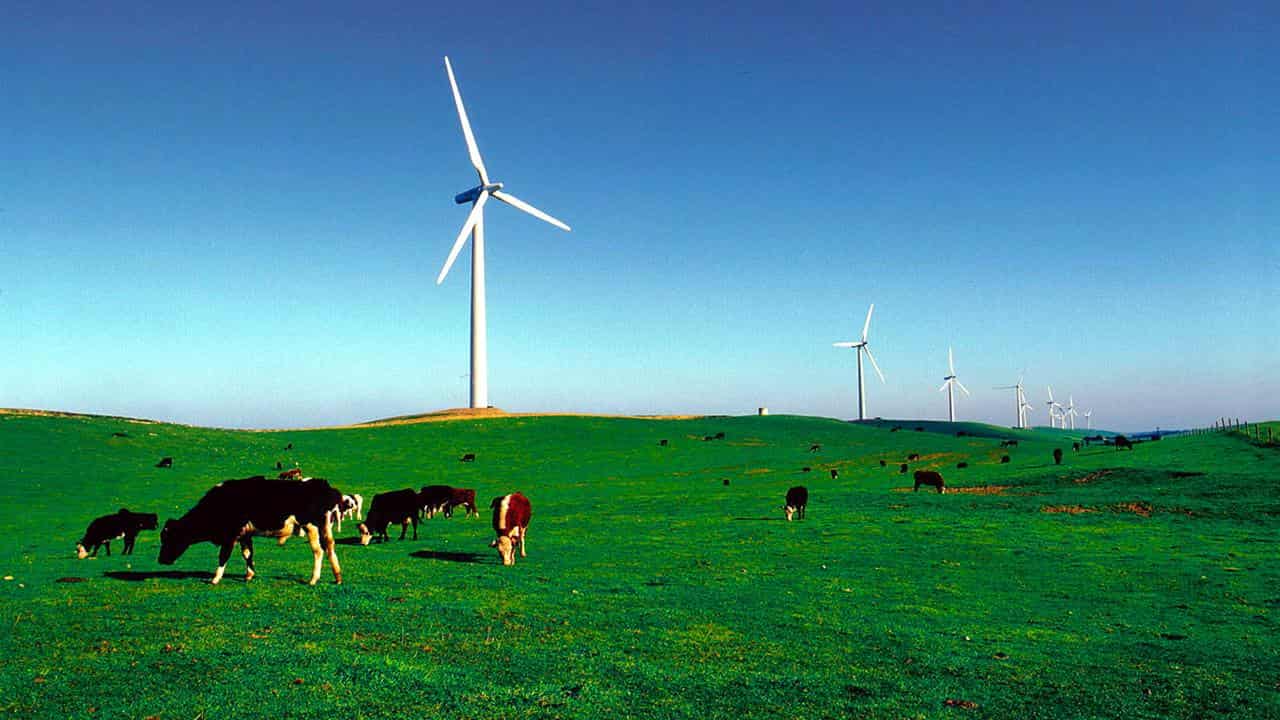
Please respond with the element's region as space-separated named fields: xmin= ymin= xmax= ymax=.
xmin=0 ymin=0 xmax=1280 ymax=429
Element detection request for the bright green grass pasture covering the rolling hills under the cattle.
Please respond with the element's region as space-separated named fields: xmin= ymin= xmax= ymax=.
xmin=0 ymin=414 xmax=1280 ymax=720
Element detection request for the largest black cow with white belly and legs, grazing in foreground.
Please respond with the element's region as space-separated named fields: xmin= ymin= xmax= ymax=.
xmin=160 ymin=475 xmax=342 ymax=585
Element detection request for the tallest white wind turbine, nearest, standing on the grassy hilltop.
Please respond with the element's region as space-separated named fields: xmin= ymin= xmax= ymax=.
xmin=435 ymin=56 xmax=570 ymax=407
